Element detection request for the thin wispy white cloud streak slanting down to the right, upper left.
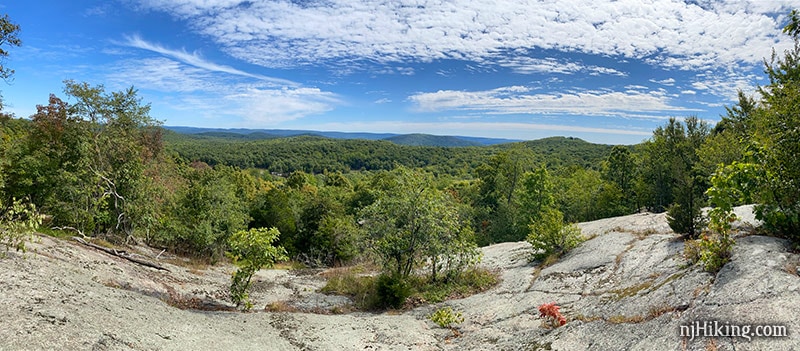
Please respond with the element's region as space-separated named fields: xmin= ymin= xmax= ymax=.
xmin=121 ymin=35 xmax=298 ymax=86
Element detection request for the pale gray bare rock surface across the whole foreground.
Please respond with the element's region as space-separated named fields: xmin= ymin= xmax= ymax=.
xmin=0 ymin=207 xmax=800 ymax=350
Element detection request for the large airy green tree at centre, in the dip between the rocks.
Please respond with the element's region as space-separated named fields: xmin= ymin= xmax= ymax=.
xmin=360 ymin=167 xmax=478 ymax=280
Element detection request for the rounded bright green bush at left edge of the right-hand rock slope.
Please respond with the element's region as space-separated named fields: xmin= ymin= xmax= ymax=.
xmin=528 ymin=208 xmax=584 ymax=260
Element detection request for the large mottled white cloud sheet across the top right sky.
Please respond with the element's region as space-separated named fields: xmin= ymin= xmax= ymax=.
xmin=140 ymin=0 xmax=796 ymax=73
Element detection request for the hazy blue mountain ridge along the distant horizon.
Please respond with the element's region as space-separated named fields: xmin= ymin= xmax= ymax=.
xmin=164 ymin=126 xmax=520 ymax=147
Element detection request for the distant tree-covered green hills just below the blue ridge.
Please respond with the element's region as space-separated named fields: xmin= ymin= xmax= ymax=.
xmin=165 ymin=132 xmax=611 ymax=177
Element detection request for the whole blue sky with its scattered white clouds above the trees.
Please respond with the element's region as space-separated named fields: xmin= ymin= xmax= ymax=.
xmin=0 ymin=0 xmax=800 ymax=144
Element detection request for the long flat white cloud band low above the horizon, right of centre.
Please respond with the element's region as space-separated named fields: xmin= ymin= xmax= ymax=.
xmin=408 ymin=86 xmax=691 ymax=118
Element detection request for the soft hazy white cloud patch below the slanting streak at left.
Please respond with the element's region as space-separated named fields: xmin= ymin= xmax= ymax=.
xmin=106 ymin=57 xmax=341 ymax=127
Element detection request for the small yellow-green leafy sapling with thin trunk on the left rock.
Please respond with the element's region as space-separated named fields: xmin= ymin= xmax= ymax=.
xmin=228 ymin=228 xmax=288 ymax=309
